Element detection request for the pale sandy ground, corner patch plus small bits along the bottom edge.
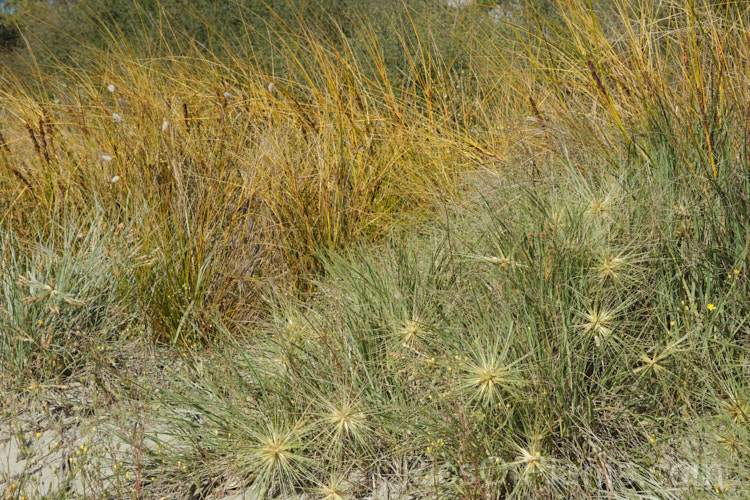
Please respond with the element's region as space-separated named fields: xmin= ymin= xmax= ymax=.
xmin=0 ymin=384 xmax=424 ymax=500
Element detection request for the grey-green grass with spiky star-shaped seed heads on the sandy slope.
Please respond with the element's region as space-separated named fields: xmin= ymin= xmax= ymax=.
xmin=140 ymin=120 xmax=750 ymax=498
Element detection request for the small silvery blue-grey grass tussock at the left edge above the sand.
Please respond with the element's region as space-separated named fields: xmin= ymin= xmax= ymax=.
xmin=0 ymin=208 xmax=134 ymax=385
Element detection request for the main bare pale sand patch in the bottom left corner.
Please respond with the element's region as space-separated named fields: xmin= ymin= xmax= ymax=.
xmin=0 ymin=384 xmax=130 ymax=499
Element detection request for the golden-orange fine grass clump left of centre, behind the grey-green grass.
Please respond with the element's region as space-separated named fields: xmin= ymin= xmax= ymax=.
xmin=0 ymin=4 xmax=490 ymax=345
